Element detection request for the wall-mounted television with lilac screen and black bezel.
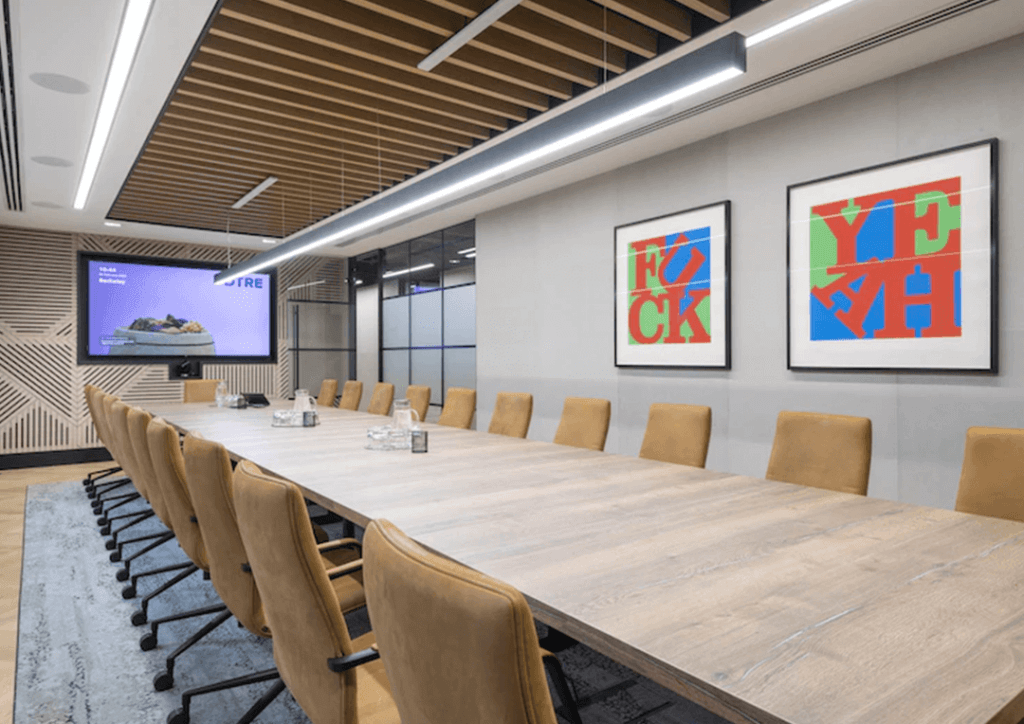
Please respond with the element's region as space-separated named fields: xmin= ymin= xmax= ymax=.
xmin=78 ymin=253 xmax=278 ymax=364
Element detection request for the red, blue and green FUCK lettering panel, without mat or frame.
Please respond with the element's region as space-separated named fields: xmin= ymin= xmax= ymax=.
xmin=629 ymin=226 xmax=711 ymax=344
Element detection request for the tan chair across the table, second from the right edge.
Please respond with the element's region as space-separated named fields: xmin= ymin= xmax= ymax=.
xmin=765 ymin=411 xmax=871 ymax=496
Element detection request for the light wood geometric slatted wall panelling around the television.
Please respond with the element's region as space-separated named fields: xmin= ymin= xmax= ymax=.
xmin=0 ymin=226 xmax=346 ymax=455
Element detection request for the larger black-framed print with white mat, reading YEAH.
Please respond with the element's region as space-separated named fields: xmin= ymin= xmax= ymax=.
xmin=786 ymin=139 xmax=997 ymax=372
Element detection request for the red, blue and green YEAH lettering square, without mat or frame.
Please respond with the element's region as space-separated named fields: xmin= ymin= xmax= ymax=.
xmin=810 ymin=177 xmax=961 ymax=340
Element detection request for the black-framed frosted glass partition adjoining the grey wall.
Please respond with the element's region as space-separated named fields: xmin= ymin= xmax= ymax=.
xmin=379 ymin=221 xmax=476 ymax=419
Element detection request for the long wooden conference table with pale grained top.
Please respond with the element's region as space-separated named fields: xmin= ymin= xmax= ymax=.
xmin=148 ymin=403 xmax=1024 ymax=724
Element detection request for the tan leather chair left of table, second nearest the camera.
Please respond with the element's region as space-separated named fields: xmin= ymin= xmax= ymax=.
xmin=234 ymin=461 xmax=395 ymax=724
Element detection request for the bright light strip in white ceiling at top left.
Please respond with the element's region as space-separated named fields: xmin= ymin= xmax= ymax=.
xmin=74 ymin=0 xmax=153 ymax=211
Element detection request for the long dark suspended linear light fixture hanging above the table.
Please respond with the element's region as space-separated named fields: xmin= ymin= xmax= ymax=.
xmin=215 ymin=33 xmax=746 ymax=284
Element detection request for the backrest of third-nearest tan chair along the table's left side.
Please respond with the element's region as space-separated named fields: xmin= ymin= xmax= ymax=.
xmin=183 ymin=432 xmax=270 ymax=636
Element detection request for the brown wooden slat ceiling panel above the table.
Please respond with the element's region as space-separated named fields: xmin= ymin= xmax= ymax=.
xmin=109 ymin=0 xmax=759 ymax=238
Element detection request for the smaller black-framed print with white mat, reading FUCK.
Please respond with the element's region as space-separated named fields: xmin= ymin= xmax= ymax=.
xmin=614 ymin=201 xmax=729 ymax=370
